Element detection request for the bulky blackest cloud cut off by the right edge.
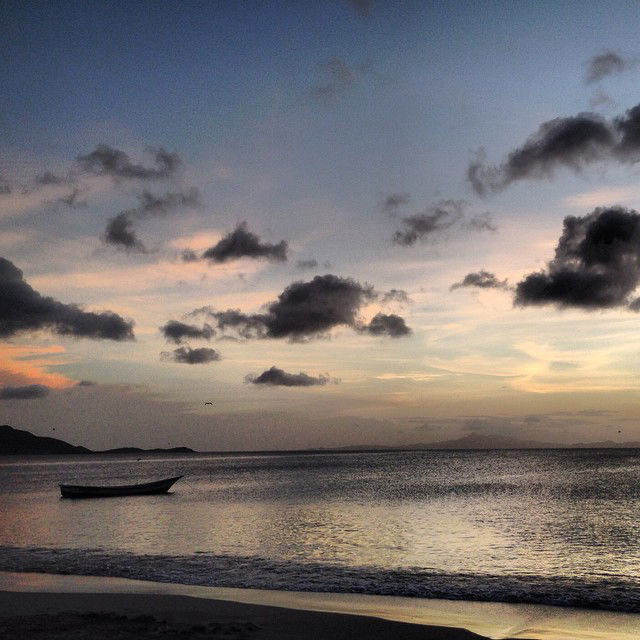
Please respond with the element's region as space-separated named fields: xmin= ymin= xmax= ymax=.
xmin=515 ymin=207 xmax=640 ymax=311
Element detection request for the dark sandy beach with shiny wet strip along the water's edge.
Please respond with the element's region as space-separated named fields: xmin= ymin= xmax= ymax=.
xmin=0 ymin=572 xmax=640 ymax=640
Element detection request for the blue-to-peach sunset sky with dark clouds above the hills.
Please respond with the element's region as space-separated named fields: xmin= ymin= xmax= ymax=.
xmin=0 ymin=0 xmax=640 ymax=451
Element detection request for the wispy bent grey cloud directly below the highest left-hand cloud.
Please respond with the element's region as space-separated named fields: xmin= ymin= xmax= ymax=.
xmin=102 ymin=188 xmax=201 ymax=253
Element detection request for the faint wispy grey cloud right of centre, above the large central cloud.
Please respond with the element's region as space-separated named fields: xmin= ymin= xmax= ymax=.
xmin=393 ymin=200 xmax=497 ymax=247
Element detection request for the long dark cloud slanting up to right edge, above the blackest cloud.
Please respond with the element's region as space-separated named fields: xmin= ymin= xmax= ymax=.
xmin=467 ymin=104 xmax=640 ymax=195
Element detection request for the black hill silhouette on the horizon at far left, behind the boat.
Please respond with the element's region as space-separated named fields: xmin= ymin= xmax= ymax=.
xmin=0 ymin=424 xmax=195 ymax=456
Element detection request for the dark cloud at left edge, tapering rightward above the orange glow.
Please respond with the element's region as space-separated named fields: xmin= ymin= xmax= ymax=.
xmin=0 ymin=258 xmax=133 ymax=340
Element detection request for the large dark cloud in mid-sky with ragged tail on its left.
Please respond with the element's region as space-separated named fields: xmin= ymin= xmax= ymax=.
xmin=189 ymin=274 xmax=408 ymax=341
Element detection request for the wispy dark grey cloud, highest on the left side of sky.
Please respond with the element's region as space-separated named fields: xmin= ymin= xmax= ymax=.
xmin=77 ymin=144 xmax=182 ymax=180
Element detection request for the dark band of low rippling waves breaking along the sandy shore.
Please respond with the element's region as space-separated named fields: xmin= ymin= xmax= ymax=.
xmin=0 ymin=546 xmax=640 ymax=613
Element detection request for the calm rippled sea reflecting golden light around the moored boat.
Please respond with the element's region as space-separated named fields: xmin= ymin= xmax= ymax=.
xmin=0 ymin=450 xmax=640 ymax=612
